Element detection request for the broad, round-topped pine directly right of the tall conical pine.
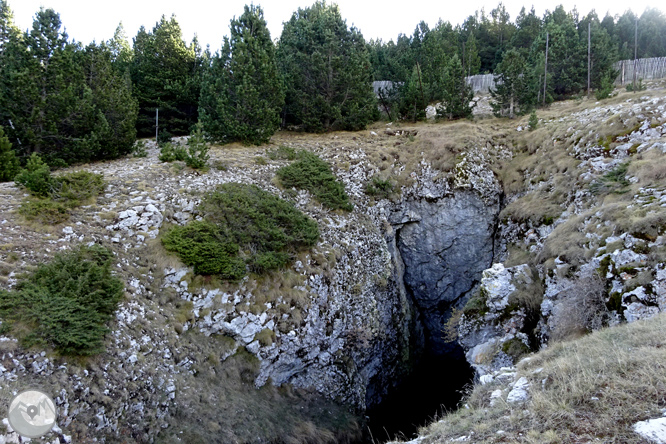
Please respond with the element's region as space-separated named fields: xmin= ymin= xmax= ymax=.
xmin=277 ymin=2 xmax=378 ymax=131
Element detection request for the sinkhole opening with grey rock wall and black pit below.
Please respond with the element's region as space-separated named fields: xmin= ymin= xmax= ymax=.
xmin=356 ymin=191 xmax=500 ymax=443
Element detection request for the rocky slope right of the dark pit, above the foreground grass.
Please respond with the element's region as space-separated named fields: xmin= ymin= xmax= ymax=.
xmin=459 ymin=93 xmax=666 ymax=375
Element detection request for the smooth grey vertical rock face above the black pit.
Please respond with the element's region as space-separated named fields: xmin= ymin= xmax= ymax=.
xmin=392 ymin=190 xmax=499 ymax=354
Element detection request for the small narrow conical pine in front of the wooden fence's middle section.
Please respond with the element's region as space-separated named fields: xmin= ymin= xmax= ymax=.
xmin=437 ymin=54 xmax=476 ymax=120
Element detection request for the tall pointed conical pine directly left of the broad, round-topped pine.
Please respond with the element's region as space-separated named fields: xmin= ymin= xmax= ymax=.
xmin=199 ymin=5 xmax=284 ymax=145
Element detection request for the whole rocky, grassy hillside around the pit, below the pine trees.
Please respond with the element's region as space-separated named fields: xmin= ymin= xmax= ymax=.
xmin=0 ymin=83 xmax=666 ymax=443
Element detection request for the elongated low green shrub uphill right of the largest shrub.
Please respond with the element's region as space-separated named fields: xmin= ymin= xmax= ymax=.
xmin=277 ymin=151 xmax=354 ymax=211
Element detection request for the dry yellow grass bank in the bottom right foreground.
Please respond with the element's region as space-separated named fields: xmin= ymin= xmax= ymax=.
xmin=410 ymin=314 xmax=666 ymax=444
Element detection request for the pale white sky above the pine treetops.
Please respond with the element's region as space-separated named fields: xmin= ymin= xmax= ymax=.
xmin=8 ymin=0 xmax=664 ymax=51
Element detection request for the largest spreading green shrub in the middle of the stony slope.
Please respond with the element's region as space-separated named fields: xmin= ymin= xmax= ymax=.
xmin=162 ymin=183 xmax=319 ymax=280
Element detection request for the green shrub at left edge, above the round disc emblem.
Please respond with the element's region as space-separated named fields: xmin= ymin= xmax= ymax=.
xmin=0 ymin=245 xmax=123 ymax=355
